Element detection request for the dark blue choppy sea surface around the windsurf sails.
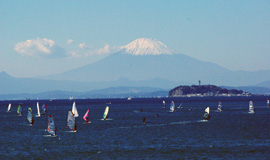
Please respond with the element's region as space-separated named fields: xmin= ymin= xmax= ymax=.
xmin=0 ymin=96 xmax=270 ymax=159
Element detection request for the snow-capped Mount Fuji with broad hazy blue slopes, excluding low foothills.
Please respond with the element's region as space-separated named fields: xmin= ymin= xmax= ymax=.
xmin=43 ymin=38 xmax=270 ymax=88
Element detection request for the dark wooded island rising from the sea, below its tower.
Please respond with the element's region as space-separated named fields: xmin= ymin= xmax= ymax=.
xmin=168 ymin=85 xmax=249 ymax=97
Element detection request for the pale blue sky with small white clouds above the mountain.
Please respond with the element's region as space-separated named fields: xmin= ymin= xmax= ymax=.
xmin=0 ymin=0 xmax=270 ymax=77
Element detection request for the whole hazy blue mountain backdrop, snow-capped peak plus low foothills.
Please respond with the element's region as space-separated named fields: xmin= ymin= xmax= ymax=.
xmin=0 ymin=38 xmax=270 ymax=99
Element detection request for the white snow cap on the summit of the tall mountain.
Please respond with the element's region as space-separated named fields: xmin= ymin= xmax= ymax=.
xmin=122 ymin=38 xmax=175 ymax=55
